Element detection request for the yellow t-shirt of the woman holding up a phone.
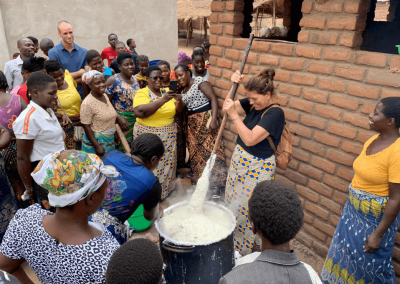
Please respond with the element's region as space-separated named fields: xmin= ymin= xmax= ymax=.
xmin=133 ymin=87 xmax=176 ymax=127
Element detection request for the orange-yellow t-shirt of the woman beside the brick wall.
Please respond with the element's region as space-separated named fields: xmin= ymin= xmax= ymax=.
xmin=351 ymin=135 xmax=400 ymax=196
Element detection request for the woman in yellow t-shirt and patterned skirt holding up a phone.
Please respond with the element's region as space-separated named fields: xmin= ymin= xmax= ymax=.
xmin=133 ymin=66 xmax=184 ymax=199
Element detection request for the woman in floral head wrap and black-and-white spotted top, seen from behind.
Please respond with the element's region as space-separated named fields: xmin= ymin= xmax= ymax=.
xmin=0 ymin=150 xmax=119 ymax=284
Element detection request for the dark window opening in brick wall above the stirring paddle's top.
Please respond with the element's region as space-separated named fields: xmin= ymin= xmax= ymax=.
xmin=241 ymin=0 xmax=303 ymax=42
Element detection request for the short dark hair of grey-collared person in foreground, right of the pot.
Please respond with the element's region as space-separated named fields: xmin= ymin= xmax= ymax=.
xmin=249 ymin=180 xmax=304 ymax=245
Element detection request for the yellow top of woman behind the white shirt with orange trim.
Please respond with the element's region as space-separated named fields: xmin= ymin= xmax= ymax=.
xmin=57 ymin=70 xmax=81 ymax=117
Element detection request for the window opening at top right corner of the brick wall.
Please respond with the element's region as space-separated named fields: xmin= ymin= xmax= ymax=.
xmin=361 ymin=0 xmax=400 ymax=54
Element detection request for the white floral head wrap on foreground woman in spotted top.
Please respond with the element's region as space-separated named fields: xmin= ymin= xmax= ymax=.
xmin=31 ymin=151 xmax=119 ymax=207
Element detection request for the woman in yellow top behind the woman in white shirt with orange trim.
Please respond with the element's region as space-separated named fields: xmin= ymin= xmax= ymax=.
xmin=44 ymin=60 xmax=81 ymax=149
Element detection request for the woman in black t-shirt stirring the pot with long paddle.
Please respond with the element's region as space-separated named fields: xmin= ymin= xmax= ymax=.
xmin=223 ymin=69 xmax=285 ymax=255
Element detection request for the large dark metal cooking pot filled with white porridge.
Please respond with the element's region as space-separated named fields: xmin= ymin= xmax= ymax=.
xmin=155 ymin=201 xmax=236 ymax=284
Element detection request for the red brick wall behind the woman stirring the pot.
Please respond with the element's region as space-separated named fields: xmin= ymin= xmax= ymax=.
xmin=209 ymin=0 xmax=400 ymax=274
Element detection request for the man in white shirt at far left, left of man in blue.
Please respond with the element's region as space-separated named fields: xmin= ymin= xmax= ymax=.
xmin=4 ymin=38 xmax=35 ymax=92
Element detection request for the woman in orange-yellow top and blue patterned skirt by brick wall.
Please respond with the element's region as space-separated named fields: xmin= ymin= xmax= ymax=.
xmin=321 ymin=97 xmax=400 ymax=283
